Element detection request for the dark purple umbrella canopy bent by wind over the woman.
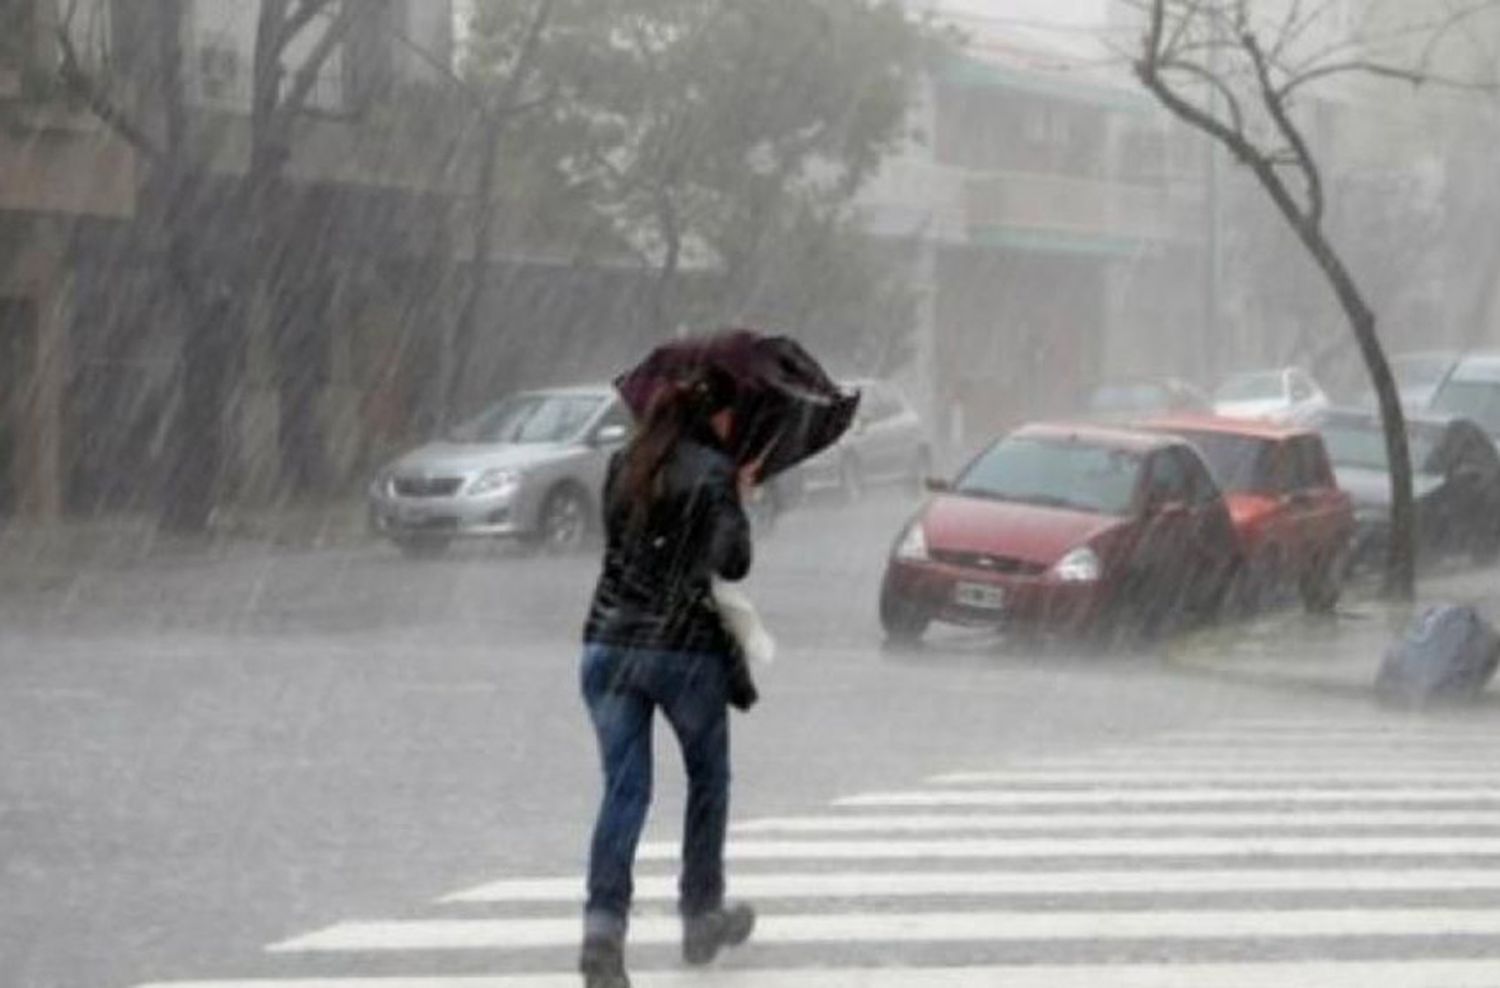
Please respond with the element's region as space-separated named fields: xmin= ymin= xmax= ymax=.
xmin=615 ymin=330 xmax=860 ymax=478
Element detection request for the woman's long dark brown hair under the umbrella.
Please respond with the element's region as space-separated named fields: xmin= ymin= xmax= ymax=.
xmin=617 ymin=366 xmax=737 ymax=519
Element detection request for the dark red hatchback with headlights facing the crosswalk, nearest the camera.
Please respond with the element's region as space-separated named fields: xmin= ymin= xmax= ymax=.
xmin=881 ymin=424 xmax=1239 ymax=642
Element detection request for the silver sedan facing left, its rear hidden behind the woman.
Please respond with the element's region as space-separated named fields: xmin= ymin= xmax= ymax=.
xmin=369 ymin=385 xmax=632 ymax=556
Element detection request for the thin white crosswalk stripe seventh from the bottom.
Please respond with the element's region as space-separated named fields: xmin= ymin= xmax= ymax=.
xmin=926 ymin=760 xmax=1500 ymax=789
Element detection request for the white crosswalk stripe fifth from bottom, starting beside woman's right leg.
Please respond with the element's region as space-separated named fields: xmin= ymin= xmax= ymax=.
xmin=734 ymin=808 xmax=1500 ymax=834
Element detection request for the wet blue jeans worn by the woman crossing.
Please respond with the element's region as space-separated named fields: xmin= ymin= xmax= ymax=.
xmin=581 ymin=645 xmax=729 ymax=939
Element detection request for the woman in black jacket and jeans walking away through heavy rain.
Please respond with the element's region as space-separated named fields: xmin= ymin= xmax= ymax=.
xmin=579 ymin=367 xmax=755 ymax=988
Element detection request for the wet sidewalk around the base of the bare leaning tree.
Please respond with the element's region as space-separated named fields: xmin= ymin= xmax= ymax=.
xmin=1166 ymin=568 xmax=1500 ymax=697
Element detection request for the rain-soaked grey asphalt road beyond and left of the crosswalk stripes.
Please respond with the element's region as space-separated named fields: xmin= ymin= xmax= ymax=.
xmin=0 ymin=496 xmax=1392 ymax=988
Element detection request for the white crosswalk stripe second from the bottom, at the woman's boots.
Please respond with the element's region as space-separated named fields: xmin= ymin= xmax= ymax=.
xmin=267 ymin=909 xmax=1500 ymax=954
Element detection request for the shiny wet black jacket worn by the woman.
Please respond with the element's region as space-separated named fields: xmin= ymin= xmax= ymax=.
xmin=584 ymin=436 xmax=750 ymax=658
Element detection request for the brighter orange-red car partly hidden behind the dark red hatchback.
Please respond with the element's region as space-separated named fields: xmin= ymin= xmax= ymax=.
xmin=1142 ymin=415 xmax=1355 ymax=612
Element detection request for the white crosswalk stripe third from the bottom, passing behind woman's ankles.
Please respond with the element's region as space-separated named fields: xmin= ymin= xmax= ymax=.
xmin=441 ymin=865 xmax=1500 ymax=904
